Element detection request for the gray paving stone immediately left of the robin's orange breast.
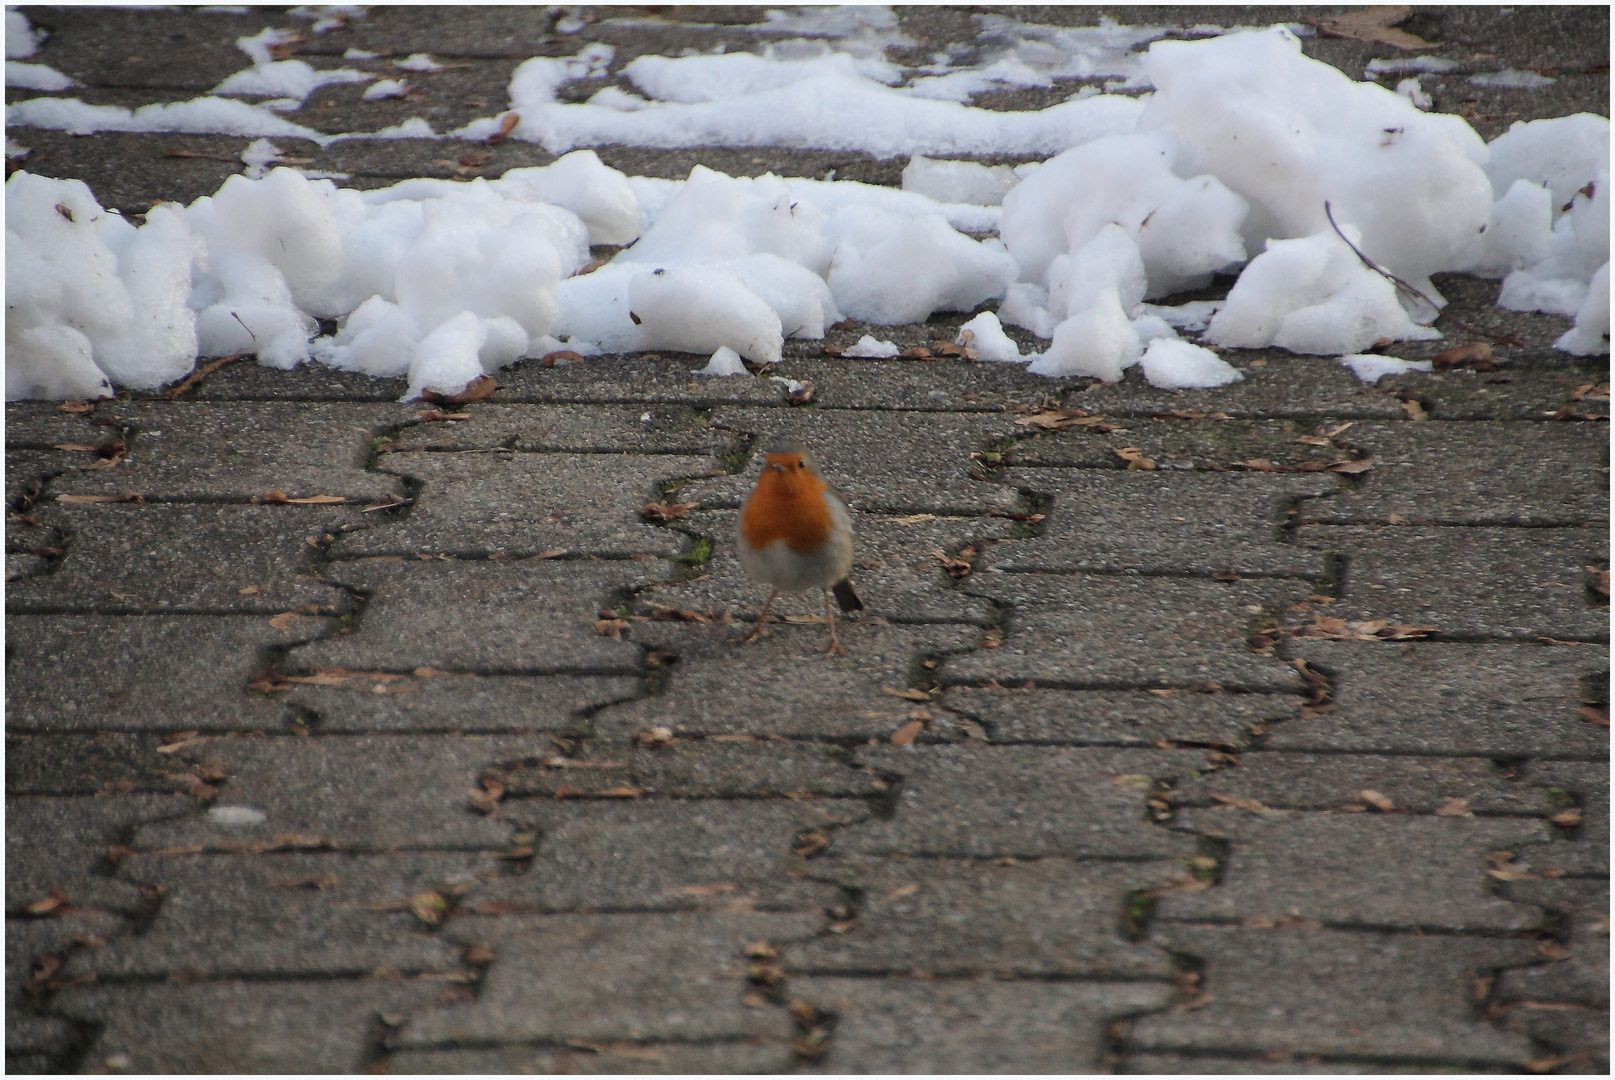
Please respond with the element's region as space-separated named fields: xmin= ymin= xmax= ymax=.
xmin=334 ymin=454 xmax=722 ymax=559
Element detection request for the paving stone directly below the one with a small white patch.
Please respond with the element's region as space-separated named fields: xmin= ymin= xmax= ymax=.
xmin=63 ymin=851 xmax=499 ymax=982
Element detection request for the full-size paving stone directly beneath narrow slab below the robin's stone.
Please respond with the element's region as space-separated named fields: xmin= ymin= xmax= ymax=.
xmin=475 ymin=799 xmax=869 ymax=914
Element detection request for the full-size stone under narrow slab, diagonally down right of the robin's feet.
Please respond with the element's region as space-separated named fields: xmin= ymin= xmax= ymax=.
xmin=828 ymin=746 xmax=1206 ymax=859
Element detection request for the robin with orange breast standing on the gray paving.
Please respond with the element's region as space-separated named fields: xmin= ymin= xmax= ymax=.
xmin=740 ymin=442 xmax=864 ymax=655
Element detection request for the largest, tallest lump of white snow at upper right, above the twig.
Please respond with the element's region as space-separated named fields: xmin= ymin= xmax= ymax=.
xmin=1139 ymin=29 xmax=1492 ymax=303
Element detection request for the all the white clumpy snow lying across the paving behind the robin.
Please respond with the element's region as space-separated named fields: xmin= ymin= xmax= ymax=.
xmin=6 ymin=16 xmax=1609 ymax=399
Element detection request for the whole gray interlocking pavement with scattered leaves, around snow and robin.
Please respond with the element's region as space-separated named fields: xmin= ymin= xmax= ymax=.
xmin=5 ymin=6 xmax=1610 ymax=1074
